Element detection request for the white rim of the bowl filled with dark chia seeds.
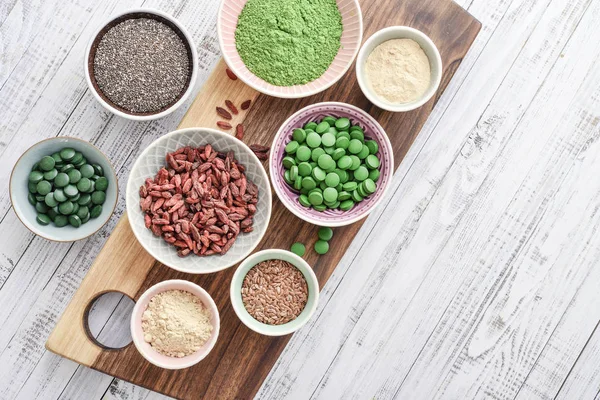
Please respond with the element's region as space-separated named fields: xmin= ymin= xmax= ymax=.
xmin=83 ymin=7 xmax=198 ymax=121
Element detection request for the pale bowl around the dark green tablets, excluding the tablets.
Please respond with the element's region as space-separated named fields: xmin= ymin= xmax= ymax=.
xmin=9 ymin=136 xmax=119 ymax=242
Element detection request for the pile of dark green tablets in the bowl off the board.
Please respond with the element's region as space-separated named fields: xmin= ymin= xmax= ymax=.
xmin=27 ymin=147 xmax=108 ymax=228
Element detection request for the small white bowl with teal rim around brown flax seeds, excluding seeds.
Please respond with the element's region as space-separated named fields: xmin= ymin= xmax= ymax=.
xmin=230 ymin=249 xmax=319 ymax=336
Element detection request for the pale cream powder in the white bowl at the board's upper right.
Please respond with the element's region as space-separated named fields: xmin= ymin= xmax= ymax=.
xmin=365 ymin=39 xmax=431 ymax=104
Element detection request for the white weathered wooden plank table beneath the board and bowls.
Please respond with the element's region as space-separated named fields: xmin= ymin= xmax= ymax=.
xmin=0 ymin=0 xmax=600 ymax=399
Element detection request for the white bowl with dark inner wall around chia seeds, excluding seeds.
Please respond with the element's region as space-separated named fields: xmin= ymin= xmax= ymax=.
xmin=83 ymin=8 xmax=198 ymax=121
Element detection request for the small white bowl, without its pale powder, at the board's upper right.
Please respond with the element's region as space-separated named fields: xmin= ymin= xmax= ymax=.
xmin=356 ymin=26 xmax=442 ymax=112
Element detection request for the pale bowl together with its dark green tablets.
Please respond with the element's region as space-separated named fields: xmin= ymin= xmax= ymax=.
xmin=10 ymin=137 xmax=118 ymax=242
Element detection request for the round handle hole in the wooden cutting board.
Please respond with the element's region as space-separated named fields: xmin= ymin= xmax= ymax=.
xmin=83 ymin=292 xmax=135 ymax=350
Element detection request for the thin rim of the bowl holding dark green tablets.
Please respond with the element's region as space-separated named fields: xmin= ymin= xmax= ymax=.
xmin=8 ymin=136 xmax=119 ymax=243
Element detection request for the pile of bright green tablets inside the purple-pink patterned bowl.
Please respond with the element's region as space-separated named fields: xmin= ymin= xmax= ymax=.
xmin=282 ymin=116 xmax=381 ymax=211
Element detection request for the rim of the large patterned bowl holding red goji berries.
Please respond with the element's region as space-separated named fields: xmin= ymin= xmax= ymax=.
xmin=125 ymin=127 xmax=273 ymax=275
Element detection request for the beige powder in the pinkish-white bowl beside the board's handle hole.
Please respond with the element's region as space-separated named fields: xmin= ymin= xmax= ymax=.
xmin=142 ymin=290 xmax=213 ymax=357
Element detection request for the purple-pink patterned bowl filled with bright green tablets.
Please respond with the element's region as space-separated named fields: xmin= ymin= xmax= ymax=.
xmin=269 ymin=102 xmax=394 ymax=227
